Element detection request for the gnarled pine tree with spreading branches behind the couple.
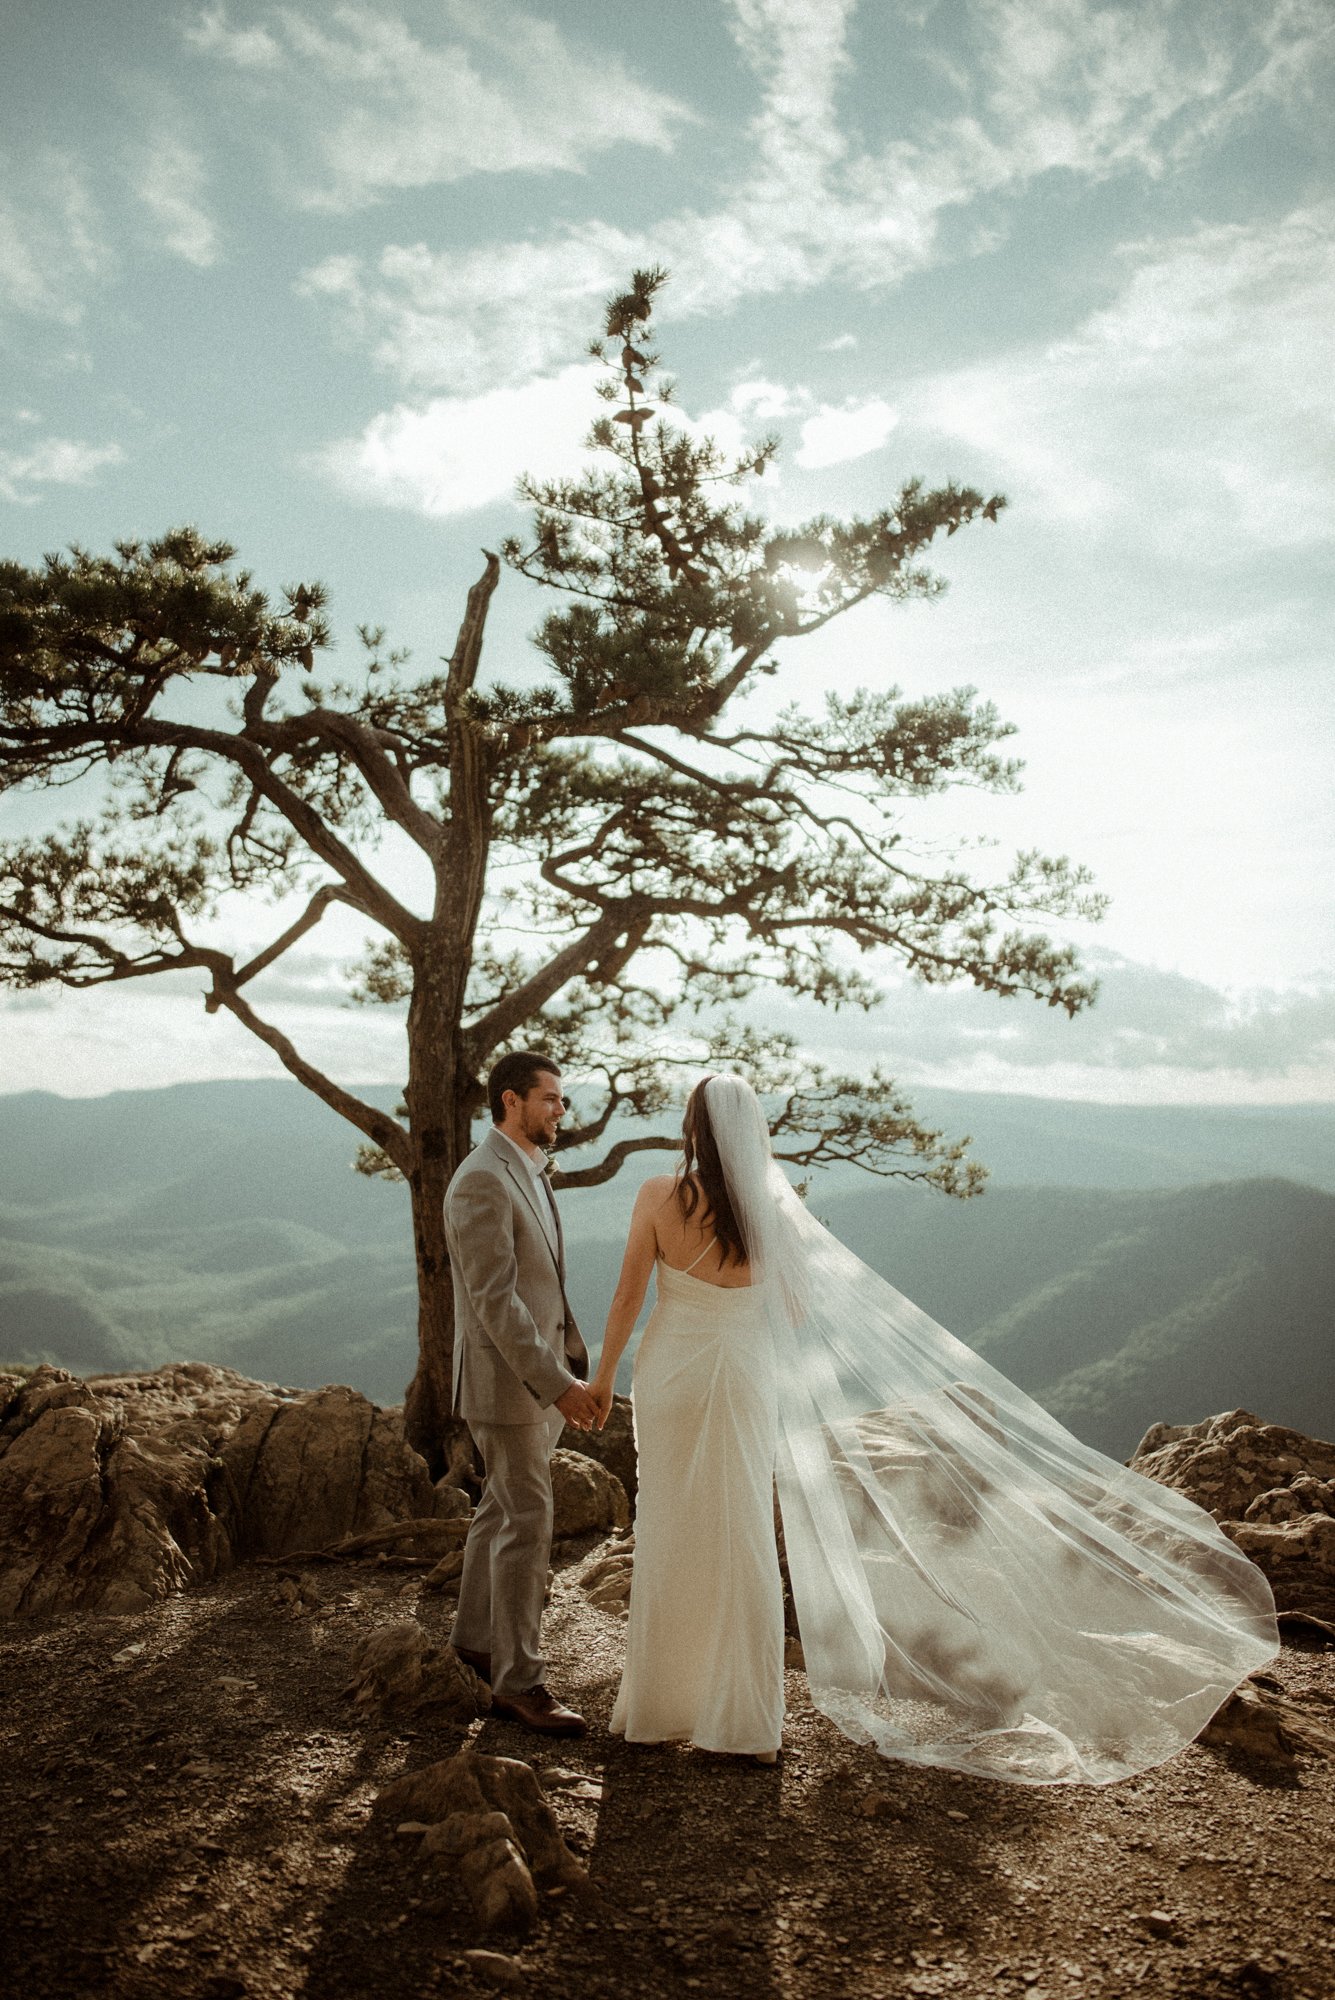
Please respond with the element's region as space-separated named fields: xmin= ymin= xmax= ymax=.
xmin=0 ymin=270 xmax=1099 ymax=1456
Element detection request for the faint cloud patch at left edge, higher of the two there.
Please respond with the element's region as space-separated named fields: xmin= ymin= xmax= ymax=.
xmin=0 ymin=150 xmax=110 ymax=326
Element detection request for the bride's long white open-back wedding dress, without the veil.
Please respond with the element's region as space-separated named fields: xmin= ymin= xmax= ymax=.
xmin=612 ymin=1238 xmax=783 ymax=1754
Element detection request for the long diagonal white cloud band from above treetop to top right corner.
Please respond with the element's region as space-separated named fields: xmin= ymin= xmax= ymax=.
xmin=304 ymin=0 xmax=1333 ymax=392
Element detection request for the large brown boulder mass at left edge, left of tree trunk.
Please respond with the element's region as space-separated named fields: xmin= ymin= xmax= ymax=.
xmin=0 ymin=1362 xmax=450 ymax=1616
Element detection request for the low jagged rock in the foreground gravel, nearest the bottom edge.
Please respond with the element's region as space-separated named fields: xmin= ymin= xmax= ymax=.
xmin=376 ymin=1750 xmax=588 ymax=1934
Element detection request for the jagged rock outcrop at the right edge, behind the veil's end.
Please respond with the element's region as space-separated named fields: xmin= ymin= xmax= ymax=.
xmin=1131 ymin=1410 xmax=1335 ymax=1624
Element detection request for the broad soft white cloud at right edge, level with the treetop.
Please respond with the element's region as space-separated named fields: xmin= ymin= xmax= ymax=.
xmin=903 ymin=202 xmax=1335 ymax=556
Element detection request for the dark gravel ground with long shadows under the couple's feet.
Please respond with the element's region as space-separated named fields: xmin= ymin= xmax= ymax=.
xmin=0 ymin=1542 xmax=1335 ymax=2000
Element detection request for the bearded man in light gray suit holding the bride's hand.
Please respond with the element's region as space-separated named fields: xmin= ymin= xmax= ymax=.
xmin=446 ymin=1052 xmax=598 ymax=1736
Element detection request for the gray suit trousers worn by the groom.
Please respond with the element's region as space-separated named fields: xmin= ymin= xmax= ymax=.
xmin=450 ymin=1410 xmax=566 ymax=1694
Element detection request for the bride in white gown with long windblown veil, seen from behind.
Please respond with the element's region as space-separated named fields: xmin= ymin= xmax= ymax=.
xmin=590 ymin=1076 xmax=1277 ymax=1784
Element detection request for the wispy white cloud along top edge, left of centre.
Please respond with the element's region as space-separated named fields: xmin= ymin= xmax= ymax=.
xmin=188 ymin=0 xmax=689 ymax=212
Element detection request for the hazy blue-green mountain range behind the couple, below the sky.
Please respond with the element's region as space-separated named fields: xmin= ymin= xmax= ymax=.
xmin=0 ymin=1082 xmax=1335 ymax=1456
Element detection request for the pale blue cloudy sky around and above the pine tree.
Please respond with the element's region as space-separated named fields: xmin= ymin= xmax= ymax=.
xmin=0 ymin=0 xmax=1335 ymax=1104
